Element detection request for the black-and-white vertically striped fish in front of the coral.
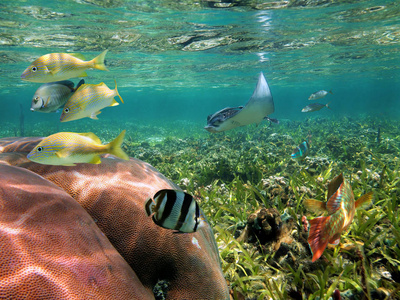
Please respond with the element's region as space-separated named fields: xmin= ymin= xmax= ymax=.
xmin=145 ymin=189 xmax=205 ymax=232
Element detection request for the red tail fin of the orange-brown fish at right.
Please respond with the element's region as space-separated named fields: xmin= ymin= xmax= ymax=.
xmin=308 ymin=216 xmax=331 ymax=262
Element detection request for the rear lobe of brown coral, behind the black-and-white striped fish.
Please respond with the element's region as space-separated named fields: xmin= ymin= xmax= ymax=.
xmin=0 ymin=138 xmax=229 ymax=299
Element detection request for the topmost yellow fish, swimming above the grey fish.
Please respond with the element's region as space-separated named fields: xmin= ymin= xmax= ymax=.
xmin=21 ymin=50 xmax=108 ymax=83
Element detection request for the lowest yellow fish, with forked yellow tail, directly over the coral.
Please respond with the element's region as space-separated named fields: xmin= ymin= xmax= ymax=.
xmin=27 ymin=130 xmax=129 ymax=166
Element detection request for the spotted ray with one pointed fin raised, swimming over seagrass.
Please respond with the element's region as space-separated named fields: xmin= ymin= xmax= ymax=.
xmin=204 ymin=72 xmax=277 ymax=132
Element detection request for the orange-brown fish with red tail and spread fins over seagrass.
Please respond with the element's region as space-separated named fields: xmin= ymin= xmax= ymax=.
xmin=304 ymin=174 xmax=373 ymax=262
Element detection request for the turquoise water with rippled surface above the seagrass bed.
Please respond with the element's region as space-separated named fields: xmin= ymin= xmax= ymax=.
xmin=0 ymin=0 xmax=400 ymax=131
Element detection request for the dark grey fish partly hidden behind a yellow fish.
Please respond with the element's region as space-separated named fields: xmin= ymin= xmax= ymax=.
xmin=31 ymin=79 xmax=85 ymax=113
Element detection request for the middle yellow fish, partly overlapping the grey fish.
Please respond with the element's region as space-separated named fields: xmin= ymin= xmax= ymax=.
xmin=60 ymin=82 xmax=124 ymax=122
